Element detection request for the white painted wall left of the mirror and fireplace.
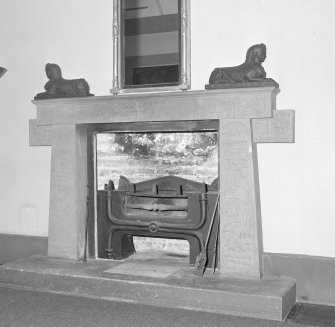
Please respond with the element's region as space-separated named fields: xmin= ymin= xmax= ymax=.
xmin=0 ymin=0 xmax=112 ymax=236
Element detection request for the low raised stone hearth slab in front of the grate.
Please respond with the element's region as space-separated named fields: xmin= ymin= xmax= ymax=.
xmin=0 ymin=253 xmax=296 ymax=321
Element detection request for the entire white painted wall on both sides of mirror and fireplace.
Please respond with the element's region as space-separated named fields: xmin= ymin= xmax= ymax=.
xmin=0 ymin=0 xmax=335 ymax=257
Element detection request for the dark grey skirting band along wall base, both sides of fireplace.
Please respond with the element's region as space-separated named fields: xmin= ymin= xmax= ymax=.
xmin=0 ymin=234 xmax=335 ymax=306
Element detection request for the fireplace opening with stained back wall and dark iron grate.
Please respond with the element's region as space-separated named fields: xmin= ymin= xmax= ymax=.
xmin=90 ymin=121 xmax=218 ymax=261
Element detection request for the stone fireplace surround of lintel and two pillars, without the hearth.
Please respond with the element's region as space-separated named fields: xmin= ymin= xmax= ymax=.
xmin=22 ymin=86 xmax=294 ymax=319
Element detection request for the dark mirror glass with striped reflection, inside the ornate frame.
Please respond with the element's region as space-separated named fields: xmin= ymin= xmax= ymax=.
xmin=121 ymin=0 xmax=180 ymax=88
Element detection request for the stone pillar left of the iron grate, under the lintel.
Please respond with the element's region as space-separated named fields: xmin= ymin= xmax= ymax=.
xmin=48 ymin=125 xmax=87 ymax=259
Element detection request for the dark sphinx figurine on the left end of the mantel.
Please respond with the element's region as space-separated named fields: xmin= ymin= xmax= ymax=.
xmin=35 ymin=64 xmax=93 ymax=100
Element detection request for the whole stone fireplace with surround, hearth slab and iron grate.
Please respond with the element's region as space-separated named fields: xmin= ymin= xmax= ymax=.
xmin=17 ymin=86 xmax=296 ymax=320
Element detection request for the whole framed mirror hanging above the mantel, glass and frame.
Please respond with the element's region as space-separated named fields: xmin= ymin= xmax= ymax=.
xmin=111 ymin=0 xmax=190 ymax=94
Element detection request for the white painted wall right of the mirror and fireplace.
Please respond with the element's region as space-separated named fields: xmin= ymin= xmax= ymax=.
xmin=192 ymin=0 xmax=335 ymax=257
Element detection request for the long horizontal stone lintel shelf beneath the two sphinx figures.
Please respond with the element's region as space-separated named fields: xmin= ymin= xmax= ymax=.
xmin=33 ymin=87 xmax=279 ymax=126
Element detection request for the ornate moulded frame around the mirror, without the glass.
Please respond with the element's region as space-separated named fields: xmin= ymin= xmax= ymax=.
xmin=110 ymin=0 xmax=191 ymax=95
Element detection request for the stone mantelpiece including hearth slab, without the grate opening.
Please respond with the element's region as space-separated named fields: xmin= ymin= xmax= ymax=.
xmin=0 ymin=87 xmax=296 ymax=321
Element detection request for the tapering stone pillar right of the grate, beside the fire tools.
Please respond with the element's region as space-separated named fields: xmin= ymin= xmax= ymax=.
xmin=220 ymin=119 xmax=263 ymax=278
